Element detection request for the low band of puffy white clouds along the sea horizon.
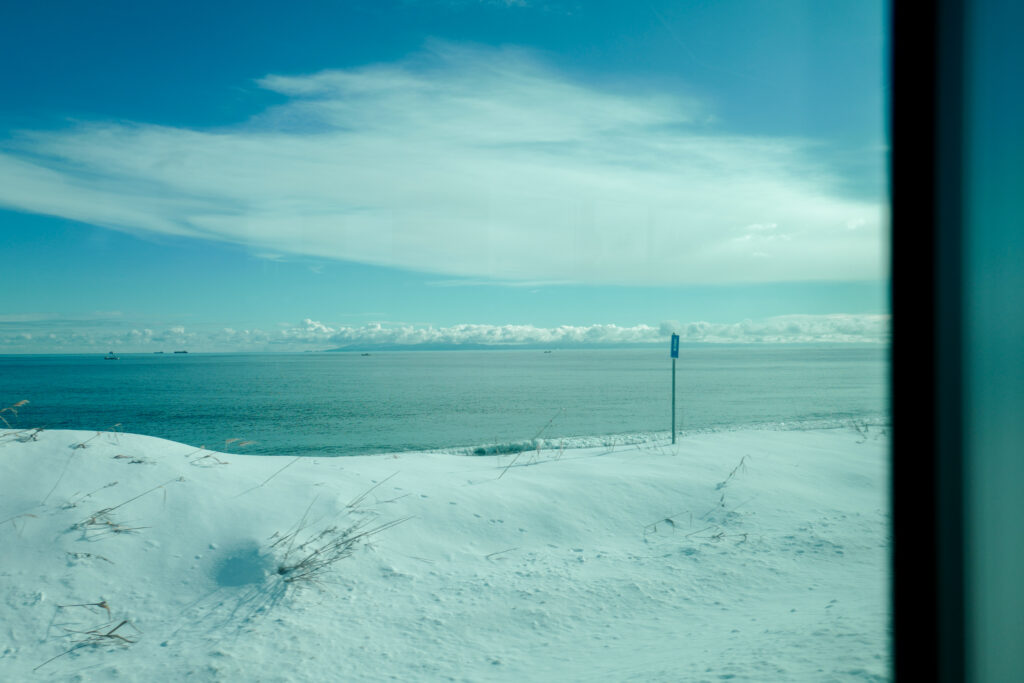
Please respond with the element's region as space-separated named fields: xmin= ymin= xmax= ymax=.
xmin=0 ymin=314 xmax=890 ymax=353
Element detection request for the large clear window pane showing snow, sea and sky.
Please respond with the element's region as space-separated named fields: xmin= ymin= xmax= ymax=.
xmin=0 ymin=0 xmax=891 ymax=680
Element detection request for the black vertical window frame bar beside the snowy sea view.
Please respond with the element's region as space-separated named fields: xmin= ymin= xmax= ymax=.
xmin=890 ymin=0 xmax=968 ymax=681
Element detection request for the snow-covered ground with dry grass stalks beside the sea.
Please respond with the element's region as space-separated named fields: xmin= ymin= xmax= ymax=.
xmin=0 ymin=426 xmax=891 ymax=682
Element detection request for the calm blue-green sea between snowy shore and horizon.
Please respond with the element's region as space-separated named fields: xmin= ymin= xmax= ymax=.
xmin=0 ymin=345 xmax=889 ymax=456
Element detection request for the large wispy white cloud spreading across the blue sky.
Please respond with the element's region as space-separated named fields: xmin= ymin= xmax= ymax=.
xmin=0 ymin=42 xmax=888 ymax=286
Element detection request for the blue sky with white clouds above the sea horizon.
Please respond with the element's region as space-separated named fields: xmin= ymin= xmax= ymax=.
xmin=0 ymin=0 xmax=889 ymax=352
